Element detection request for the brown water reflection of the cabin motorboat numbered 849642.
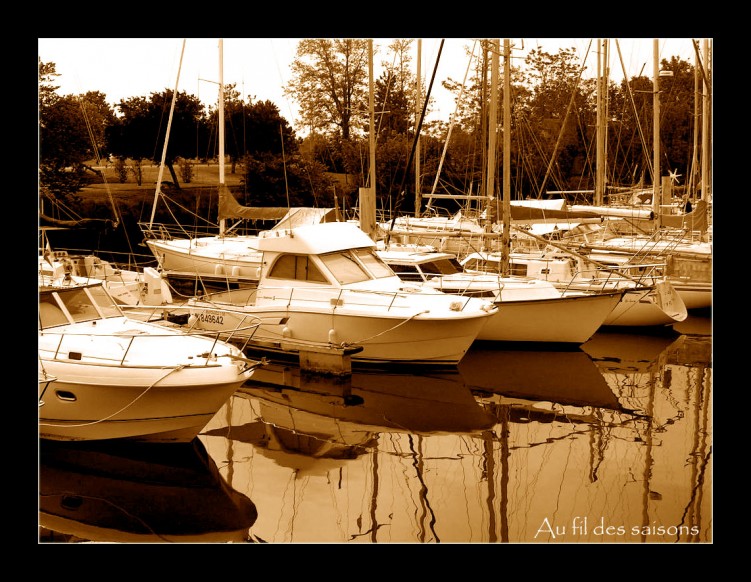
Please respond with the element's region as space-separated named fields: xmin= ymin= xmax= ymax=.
xmin=204 ymin=364 xmax=495 ymax=478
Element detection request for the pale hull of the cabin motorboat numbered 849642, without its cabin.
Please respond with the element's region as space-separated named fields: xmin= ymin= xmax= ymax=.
xmin=188 ymin=288 xmax=494 ymax=366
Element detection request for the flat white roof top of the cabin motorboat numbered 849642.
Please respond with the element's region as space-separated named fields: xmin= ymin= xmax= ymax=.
xmin=258 ymin=222 xmax=376 ymax=255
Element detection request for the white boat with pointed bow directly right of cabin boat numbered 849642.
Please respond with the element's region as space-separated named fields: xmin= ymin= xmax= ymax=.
xmin=378 ymin=250 xmax=624 ymax=344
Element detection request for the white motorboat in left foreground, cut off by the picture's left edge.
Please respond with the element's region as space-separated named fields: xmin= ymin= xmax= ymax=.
xmin=38 ymin=277 xmax=258 ymax=442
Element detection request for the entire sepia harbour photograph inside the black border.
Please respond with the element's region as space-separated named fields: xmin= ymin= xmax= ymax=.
xmin=37 ymin=37 xmax=714 ymax=546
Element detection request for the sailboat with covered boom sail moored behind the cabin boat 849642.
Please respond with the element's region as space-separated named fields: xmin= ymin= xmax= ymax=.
xmin=139 ymin=39 xmax=337 ymax=289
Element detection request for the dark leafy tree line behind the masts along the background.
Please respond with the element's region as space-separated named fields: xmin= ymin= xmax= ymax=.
xmin=39 ymin=39 xmax=712 ymax=224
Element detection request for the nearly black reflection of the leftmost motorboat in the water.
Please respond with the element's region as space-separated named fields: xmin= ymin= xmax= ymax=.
xmin=39 ymin=438 xmax=258 ymax=543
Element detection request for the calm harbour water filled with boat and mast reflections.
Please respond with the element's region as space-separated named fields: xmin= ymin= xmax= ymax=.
xmin=40 ymin=316 xmax=713 ymax=544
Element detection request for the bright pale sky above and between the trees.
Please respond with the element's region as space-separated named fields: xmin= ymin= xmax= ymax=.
xmin=38 ymin=38 xmax=701 ymax=131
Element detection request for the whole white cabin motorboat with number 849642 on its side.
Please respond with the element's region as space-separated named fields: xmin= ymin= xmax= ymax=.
xmin=188 ymin=222 xmax=497 ymax=366
